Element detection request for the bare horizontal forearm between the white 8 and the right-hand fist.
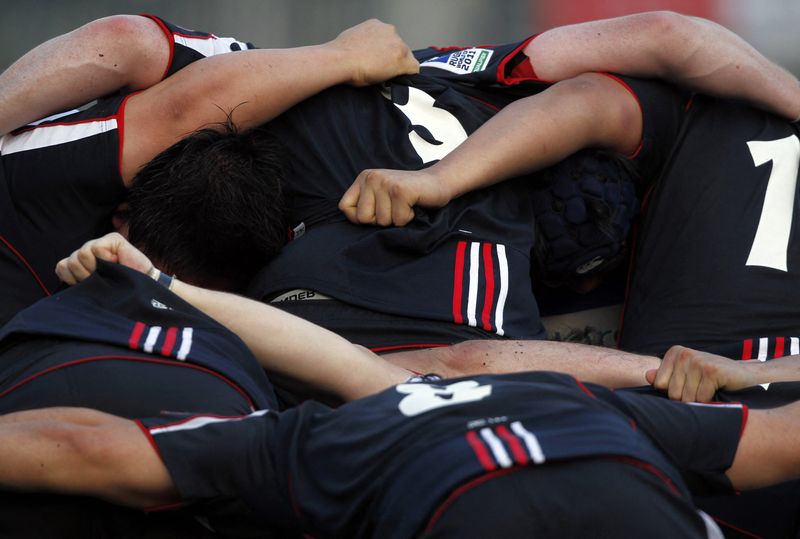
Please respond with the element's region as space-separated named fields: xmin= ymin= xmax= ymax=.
xmin=384 ymin=340 xmax=659 ymax=388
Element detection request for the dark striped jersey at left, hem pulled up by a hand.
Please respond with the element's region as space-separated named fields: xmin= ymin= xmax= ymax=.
xmin=0 ymin=261 xmax=276 ymax=415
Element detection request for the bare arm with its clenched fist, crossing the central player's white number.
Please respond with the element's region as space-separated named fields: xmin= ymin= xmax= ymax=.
xmin=339 ymin=74 xmax=642 ymax=226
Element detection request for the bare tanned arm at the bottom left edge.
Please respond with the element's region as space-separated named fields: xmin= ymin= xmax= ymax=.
xmin=0 ymin=408 xmax=173 ymax=508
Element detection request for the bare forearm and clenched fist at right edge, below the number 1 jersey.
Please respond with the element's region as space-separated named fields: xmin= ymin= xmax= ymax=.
xmin=647 ymin=346 xmax=800 ymax=402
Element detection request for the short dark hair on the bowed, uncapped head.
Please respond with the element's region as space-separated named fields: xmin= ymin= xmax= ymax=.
xmin=128 ymin=119 xmax=287 ymax=289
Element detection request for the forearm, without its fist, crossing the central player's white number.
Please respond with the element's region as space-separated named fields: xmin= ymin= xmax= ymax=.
xmin=428 ymin=75 xmax=642 ymax=202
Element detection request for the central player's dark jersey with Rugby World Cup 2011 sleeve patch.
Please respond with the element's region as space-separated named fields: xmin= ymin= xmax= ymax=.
xmin=249 ymin=42 xmax=682 ymax=346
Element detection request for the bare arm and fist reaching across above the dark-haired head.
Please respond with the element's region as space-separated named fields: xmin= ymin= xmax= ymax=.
xmin=122 ymin=20 xmax=419 ymax=181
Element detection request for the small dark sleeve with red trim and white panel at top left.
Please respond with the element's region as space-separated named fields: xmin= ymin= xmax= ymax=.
xmin=142 ymin=13 xmax=256 ymax=78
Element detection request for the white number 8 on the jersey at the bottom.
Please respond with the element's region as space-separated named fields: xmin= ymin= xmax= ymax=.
xmin=397 ymin=380 xmax=492 ymax=417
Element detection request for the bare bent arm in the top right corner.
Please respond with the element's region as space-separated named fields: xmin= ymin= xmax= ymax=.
xmin=525 ymin=11 xmax=800 ymax=120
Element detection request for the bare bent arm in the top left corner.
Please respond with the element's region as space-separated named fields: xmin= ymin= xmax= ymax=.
xmin=0 ymin=15 xmax=170 ymax=134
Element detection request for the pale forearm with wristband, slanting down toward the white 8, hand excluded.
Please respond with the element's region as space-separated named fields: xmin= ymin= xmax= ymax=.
xmin=167 ymin=281 xmax=409 ymax=400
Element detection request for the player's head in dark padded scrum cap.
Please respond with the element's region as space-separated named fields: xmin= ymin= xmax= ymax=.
xmin=534 ymin=150 xmax=639 ymax=283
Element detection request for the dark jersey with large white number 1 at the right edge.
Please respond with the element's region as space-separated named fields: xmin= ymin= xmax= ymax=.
xmin=621 ymin=98 xmax=800 ymax=360
